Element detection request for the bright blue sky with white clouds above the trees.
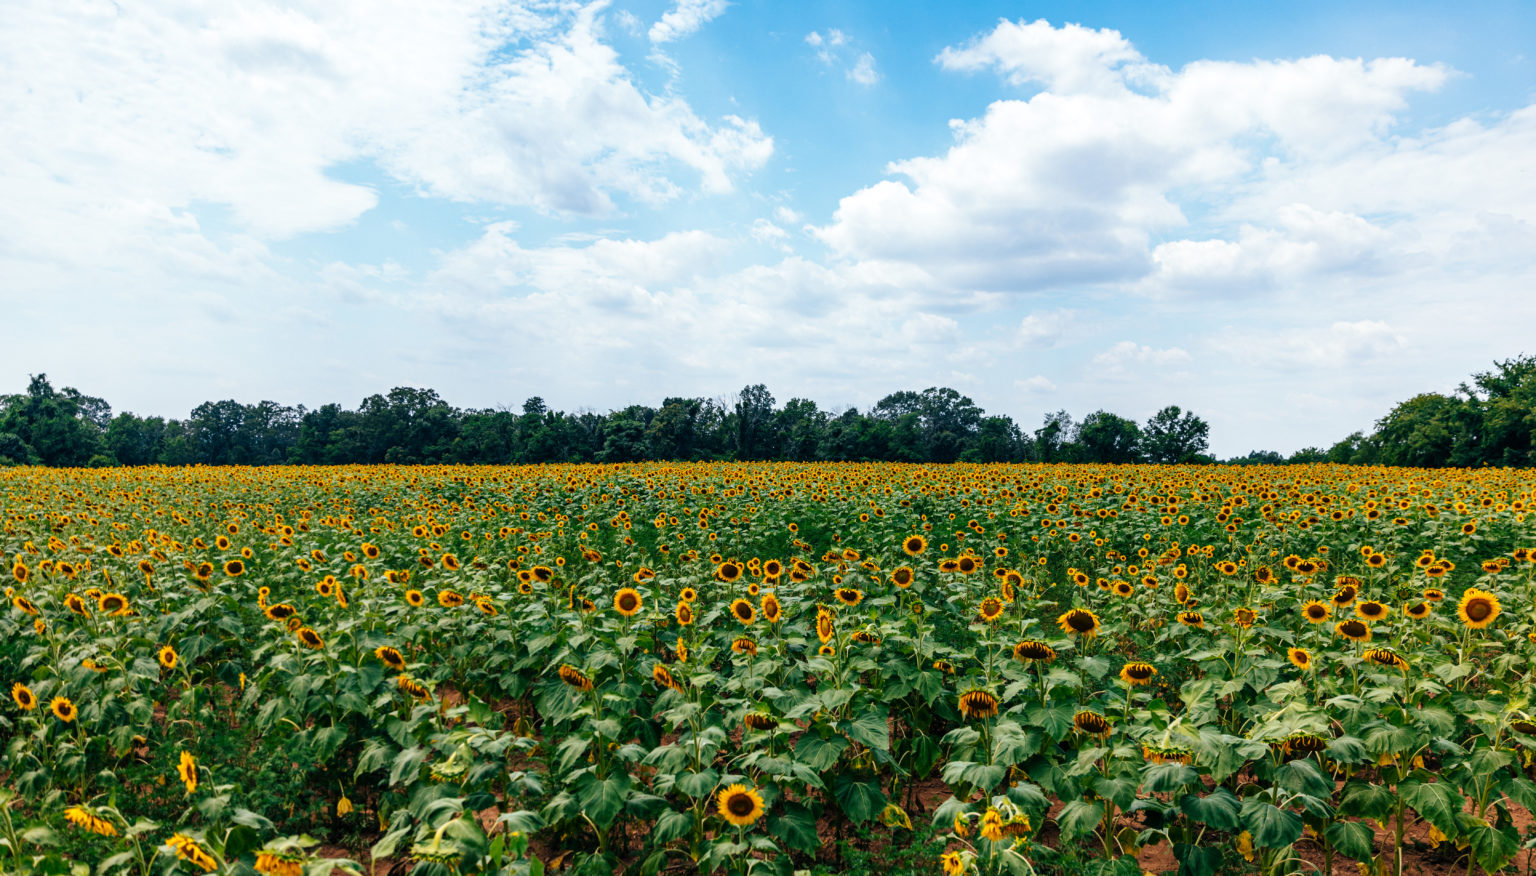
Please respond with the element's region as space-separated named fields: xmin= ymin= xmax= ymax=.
xmin=0 ymin=0 xmax=1536 ymax=456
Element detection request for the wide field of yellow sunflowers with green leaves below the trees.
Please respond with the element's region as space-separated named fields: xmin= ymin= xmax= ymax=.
xmin=0 ymin=463 xmax=1536 ymax=876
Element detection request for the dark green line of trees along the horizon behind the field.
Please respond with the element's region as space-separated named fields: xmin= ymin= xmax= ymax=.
xmin=0 ymin=355 xmax=1536 ymax=467
